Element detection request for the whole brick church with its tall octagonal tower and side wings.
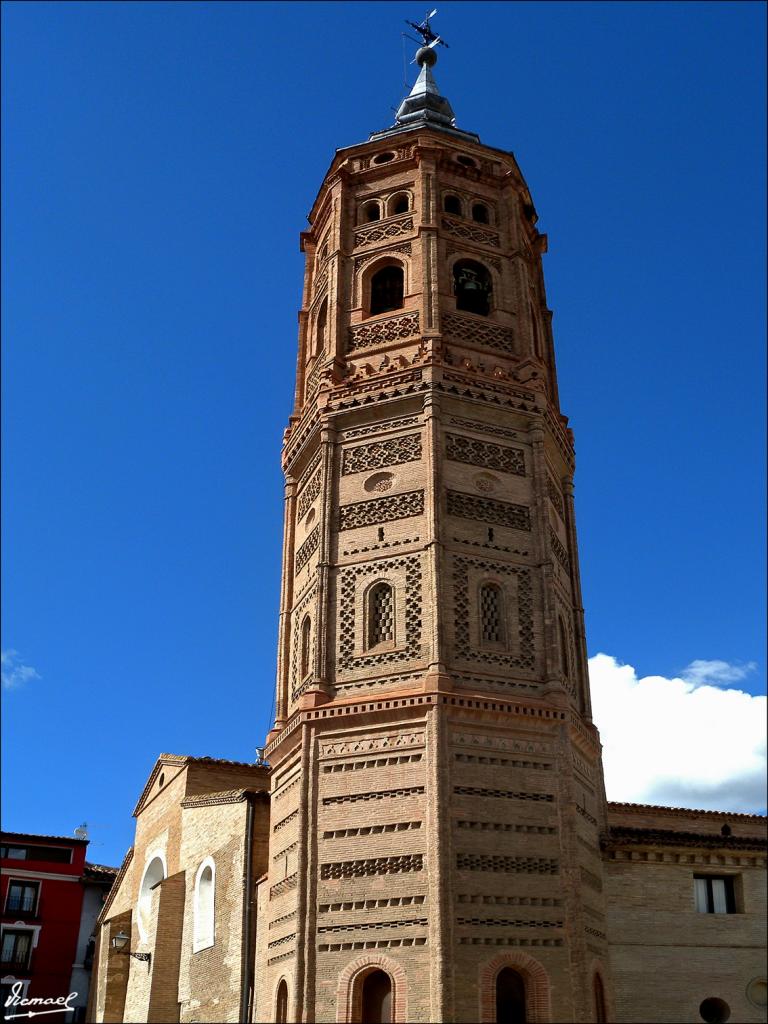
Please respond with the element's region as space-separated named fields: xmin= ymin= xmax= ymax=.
xmin=88 ymin=32 xmax=766 ymax=1024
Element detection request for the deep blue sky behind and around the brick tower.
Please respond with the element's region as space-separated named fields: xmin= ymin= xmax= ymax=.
xmin=2 ymin=2 xmax=765 ymax=863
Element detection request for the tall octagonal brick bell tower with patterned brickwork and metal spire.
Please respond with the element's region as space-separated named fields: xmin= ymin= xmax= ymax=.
xmin=259 ymin=36 xmax=610 ymax=1024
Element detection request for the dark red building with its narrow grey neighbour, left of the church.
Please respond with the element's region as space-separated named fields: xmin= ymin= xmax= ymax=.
xmin=0 ymin=833 xmax=116 ymax=1022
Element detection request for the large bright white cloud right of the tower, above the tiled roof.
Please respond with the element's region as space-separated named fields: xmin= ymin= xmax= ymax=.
xmin=589 ymin=654 xmax=767 ymax=813
